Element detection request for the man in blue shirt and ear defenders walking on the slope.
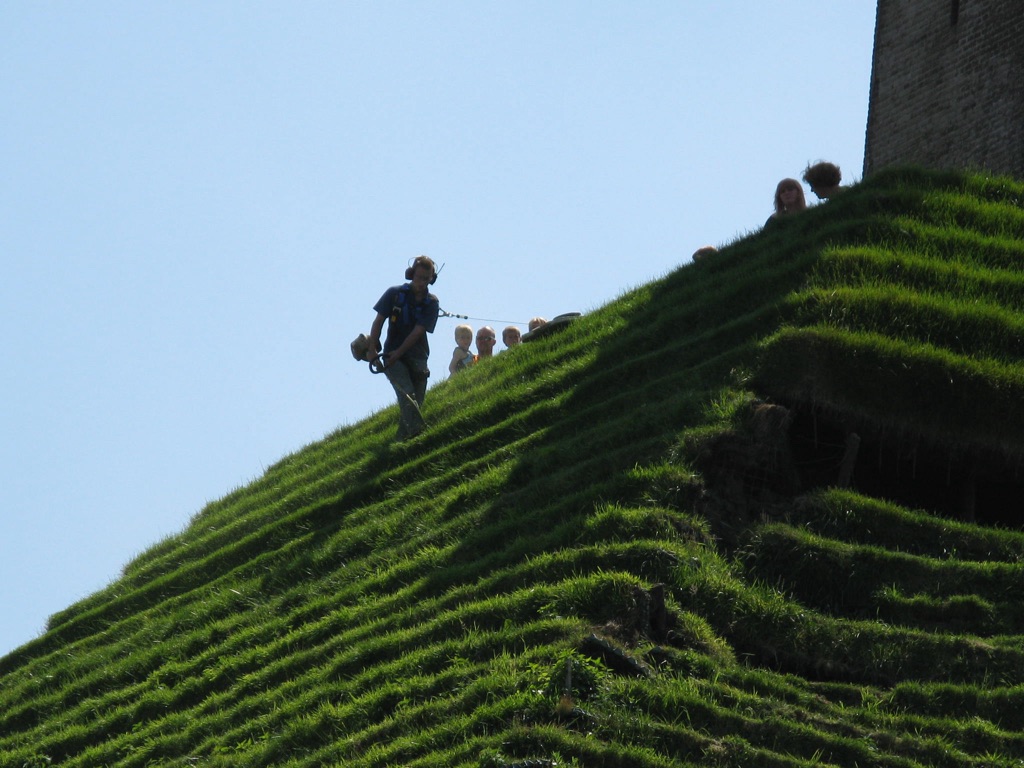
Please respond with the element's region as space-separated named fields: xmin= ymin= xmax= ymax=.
xmin=368 ymin=256 xmax=440 ymax=440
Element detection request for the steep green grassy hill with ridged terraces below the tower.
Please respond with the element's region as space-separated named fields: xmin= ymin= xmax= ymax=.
xmin=0 ymin=170 xmax=1024 ymax=768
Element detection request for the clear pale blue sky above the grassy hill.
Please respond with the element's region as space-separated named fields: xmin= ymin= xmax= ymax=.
xmin=0 ymin=0 xmax=874 ymax=654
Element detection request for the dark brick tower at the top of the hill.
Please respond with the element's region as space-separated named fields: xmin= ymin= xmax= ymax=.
xmin=864 ymin=0 xmax=1024 ymax=178
